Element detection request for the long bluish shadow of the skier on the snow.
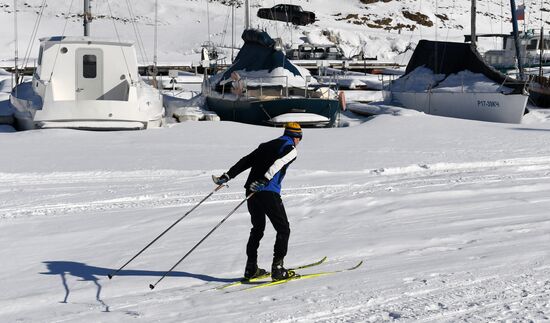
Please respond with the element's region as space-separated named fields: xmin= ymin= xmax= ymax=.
xmin=40 ymin=261 xmax=238 ymax=312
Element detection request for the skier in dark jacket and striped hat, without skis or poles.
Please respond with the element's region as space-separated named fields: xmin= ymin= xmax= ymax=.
xmin=212 ymin=122 xmax=302 ymax=281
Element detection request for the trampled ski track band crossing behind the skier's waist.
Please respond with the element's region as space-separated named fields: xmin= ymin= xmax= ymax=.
xmin=0 ymin=157 xmax=550 ymax=219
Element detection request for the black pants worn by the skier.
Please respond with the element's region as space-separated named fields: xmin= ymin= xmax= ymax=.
xmin=246 ymin=191 xmax=290 ymax=262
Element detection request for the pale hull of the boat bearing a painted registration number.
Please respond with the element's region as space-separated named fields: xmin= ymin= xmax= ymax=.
xmin=384 ymin=91 xmax=529 ymax=123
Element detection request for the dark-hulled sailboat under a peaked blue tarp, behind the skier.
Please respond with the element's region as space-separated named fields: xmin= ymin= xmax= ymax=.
xmin=202 ymin=1 xmax=341 ymax=126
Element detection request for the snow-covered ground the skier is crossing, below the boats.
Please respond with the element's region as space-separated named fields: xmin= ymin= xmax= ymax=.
xmin=0 ymin=108 xmax=550 ymax=322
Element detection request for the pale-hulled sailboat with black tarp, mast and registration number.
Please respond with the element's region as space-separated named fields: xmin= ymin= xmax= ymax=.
xmin=383 ymin=0 xmax=529 ymax=123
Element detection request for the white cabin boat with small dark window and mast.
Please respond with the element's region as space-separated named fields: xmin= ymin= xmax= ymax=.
xmin=10 ymin=0 xmax=164 ymax=130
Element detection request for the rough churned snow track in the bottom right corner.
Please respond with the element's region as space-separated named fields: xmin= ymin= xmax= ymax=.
xmin=279 ymin=267 xmax=550 ymax=322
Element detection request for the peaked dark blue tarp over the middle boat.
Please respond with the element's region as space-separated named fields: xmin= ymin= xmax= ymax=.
xmin=219 ymin=29 xmax=301 ymax=86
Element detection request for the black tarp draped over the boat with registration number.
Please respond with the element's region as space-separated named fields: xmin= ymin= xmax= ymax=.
xmin=405 ymin=39 xmax=525 ymax=94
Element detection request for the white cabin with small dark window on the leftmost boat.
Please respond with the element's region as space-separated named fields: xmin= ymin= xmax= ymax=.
xmin=33 ymin=37 xmax=139 ymax=101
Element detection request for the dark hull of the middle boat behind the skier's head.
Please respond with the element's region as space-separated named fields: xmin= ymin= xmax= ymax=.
xmin=206 ymin=96 xmax=340 ymax=126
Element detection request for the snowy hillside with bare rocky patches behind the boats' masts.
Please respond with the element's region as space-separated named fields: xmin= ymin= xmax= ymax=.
xmin=0 ymin=0 xmax=550 ymax=65
